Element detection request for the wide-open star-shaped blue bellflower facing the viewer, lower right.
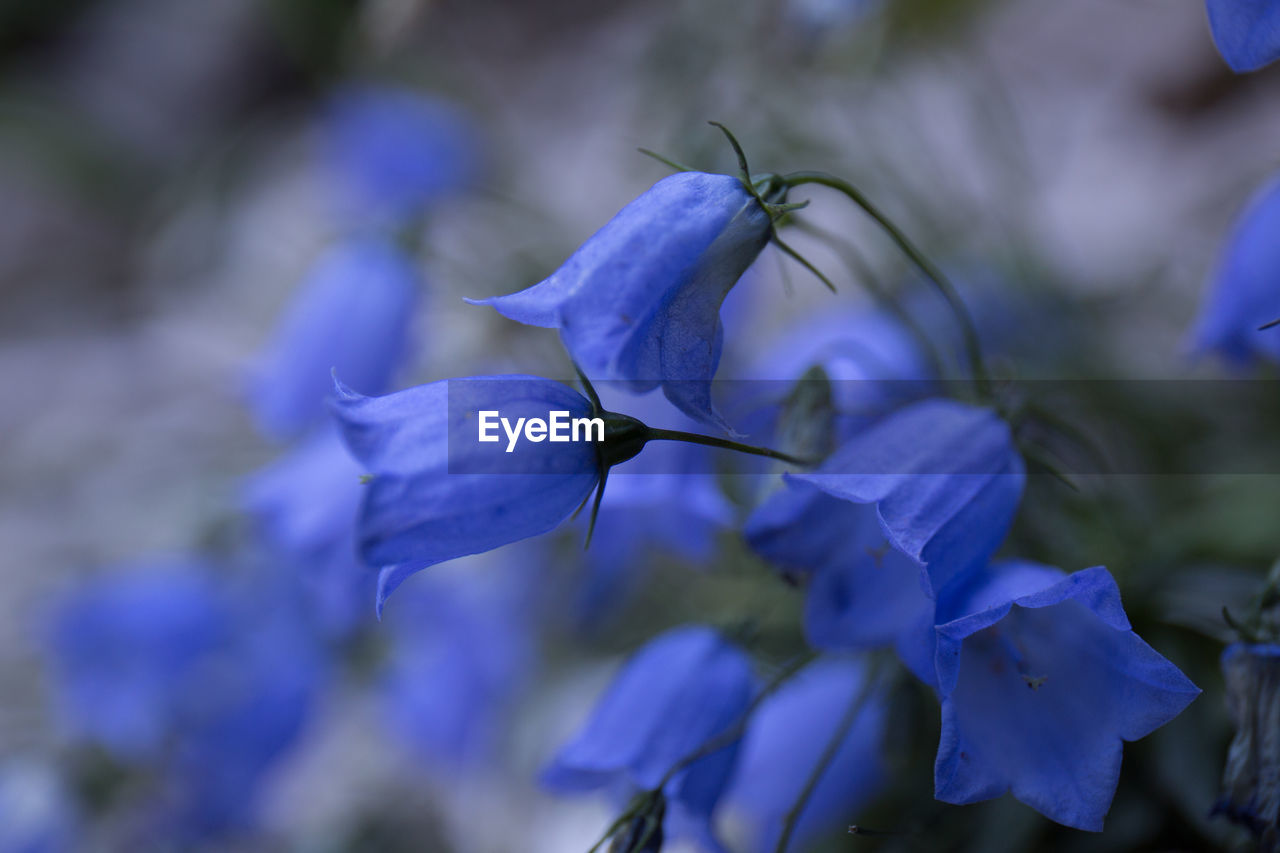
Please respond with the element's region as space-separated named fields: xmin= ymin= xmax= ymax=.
xmin=934 ymin=561 xmax=1199 ymax=831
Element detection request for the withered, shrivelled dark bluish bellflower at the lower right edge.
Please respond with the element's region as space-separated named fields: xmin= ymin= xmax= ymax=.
xmin=1213 ymin=643 xmax=1280 ymax=845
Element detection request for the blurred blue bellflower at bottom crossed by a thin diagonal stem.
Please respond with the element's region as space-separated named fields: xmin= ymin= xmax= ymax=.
xmin=723 ymin=658 xmax=888 ymax=853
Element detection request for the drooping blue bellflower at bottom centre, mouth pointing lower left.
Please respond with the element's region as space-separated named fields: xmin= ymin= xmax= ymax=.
xmin=543 ymin=626 xmax=754 ymax=848
